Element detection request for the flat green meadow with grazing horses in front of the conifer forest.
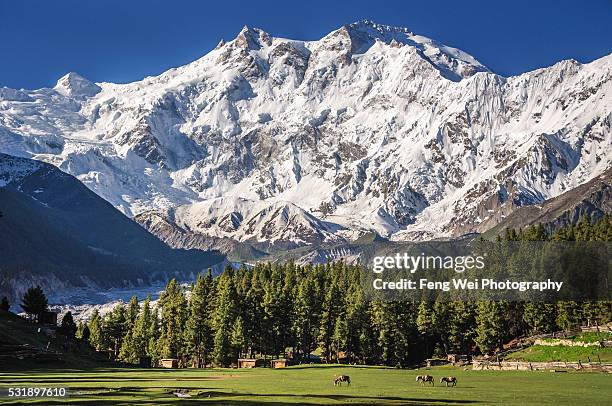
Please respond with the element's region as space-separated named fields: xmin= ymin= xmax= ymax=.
xmin=0 ymin=366 xmax=612 ymax=405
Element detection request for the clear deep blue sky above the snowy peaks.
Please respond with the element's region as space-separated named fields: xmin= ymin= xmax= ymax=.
xmin=0 ymin=0 xmax=612 ymax=89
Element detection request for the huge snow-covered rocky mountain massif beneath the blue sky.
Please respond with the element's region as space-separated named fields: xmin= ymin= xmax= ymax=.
xmin=0 ymin=21 xmax=612 ymax=246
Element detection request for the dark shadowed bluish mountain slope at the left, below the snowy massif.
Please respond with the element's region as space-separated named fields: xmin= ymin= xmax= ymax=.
xmin=0 ymin=154 xmax=223 ymax=297
